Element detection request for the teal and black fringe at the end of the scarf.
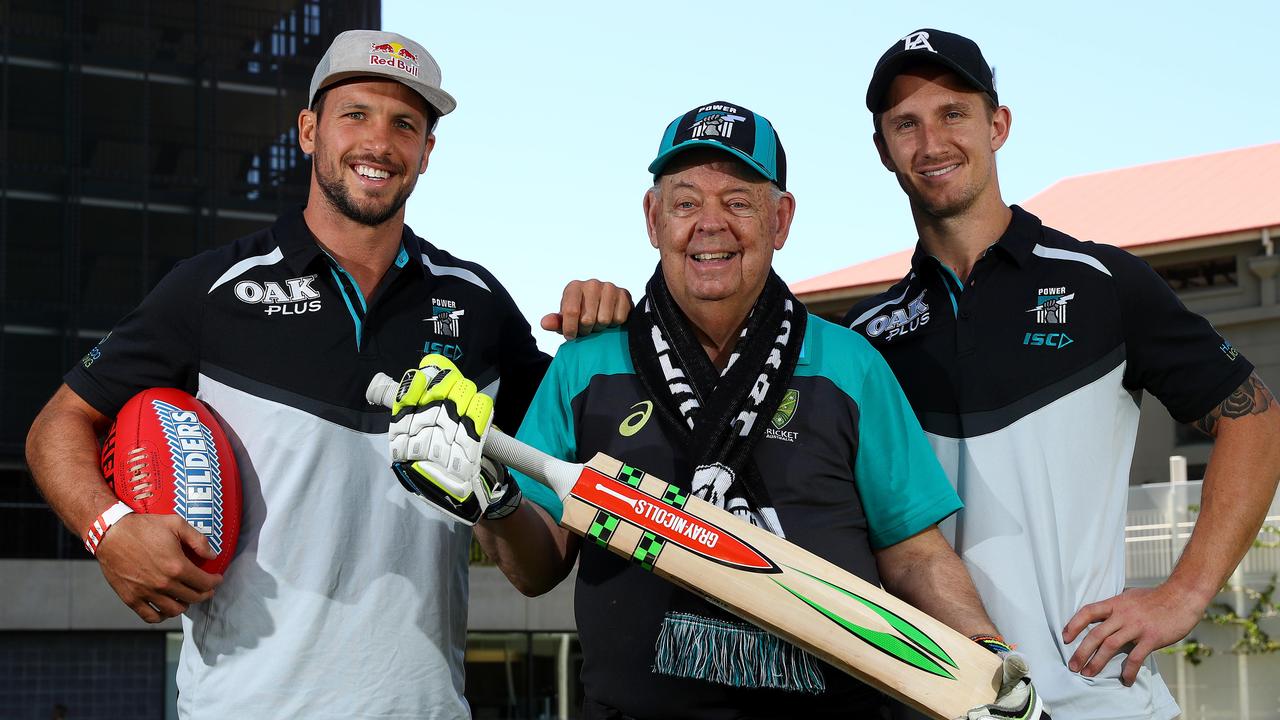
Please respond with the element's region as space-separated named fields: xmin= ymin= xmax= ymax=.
xmin=653 ymin=612 xmax=827 ymax=694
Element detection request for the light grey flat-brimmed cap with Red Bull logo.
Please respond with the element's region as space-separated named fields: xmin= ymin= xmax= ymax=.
xmin=307 ymin=29 xmax=458 ymax=115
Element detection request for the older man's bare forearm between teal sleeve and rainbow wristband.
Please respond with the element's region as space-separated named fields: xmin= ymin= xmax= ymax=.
xmin=876 ymin=528 xmax=997 ymax=637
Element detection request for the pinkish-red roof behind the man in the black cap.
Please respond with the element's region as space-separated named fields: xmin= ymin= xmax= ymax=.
xmin=791 ymin=142 xmax=1280 ymax=295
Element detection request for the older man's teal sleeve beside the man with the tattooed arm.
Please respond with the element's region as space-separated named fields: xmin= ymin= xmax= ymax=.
xmin=854 ymin=337 xmax=964 ymax=548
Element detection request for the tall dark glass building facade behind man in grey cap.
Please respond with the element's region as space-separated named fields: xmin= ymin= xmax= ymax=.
xmin=0 ymin=0 xmax=381 ymax=557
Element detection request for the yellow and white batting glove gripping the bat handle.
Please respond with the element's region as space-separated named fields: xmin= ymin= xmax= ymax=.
xmin=389 ymin=355 xmax=520 ymax=525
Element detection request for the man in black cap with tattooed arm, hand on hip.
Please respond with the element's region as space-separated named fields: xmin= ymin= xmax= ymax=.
xmin=845 ymin=29 xmax=1280 ymax=720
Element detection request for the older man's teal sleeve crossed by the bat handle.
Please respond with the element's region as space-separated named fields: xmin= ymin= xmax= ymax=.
xmin=511 ymin=346 xmax=577 ymax=523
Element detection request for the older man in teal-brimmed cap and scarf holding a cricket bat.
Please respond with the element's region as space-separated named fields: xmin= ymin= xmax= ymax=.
xmin=392 ymin=102 xmax=1042 ymax=719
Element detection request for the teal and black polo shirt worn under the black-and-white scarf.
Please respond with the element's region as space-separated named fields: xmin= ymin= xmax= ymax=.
xmin=516 ymin=315 xmax=960 ymax=719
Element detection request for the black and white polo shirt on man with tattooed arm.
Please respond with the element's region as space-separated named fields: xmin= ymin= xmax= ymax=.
xmin=845 ymin=205 xmax=1253 ymax=719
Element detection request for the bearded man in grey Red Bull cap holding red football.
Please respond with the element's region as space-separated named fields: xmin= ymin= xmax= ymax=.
xmin=27 ymin=31 xmax=630 ymax=719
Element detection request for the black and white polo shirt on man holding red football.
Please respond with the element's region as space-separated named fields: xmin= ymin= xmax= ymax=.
xmin=67 ymin=211 xmax=549 ymax=717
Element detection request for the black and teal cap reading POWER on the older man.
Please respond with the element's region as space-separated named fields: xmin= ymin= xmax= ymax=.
xmin=649 ymin=101 xmax=787 ymax=190
